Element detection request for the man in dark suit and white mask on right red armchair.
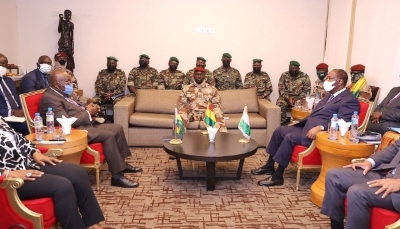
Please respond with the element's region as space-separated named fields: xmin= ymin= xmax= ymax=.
xmin=251 ymin=69 xmax=360 ymax=186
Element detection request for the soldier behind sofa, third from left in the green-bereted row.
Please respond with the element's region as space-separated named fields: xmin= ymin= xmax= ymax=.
xmin=158 ymin=57 xmax=186 ymax=90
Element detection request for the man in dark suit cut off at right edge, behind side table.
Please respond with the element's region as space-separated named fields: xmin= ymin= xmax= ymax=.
xmin=367 ymin=87 xmax=400 ymax=134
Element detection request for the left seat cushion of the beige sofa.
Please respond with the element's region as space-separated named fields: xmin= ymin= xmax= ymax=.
xmin=129 ymin=112 xmax=199 ymax=130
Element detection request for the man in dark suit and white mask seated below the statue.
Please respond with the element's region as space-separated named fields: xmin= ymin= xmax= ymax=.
xmin=21 ymin=55 xmax=52 ymax=93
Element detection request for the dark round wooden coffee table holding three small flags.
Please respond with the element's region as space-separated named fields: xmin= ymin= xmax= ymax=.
xmin=164 ymin=132 xmax=258 ymax=190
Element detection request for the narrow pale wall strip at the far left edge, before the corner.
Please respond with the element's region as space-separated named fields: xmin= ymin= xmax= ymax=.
xmin=0 ymin=0 xmax=20 ymax=64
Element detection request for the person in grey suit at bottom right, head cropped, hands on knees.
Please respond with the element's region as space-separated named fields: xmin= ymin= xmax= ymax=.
xmin=321 ymin=140 xmax=400 ymax=229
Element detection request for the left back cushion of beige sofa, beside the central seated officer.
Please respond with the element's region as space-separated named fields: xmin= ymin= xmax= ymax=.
xmin=135 ymin=89 xmax=181 ymax=114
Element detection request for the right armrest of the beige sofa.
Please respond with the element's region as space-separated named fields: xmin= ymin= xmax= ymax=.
xmin=258 ymin=99 xmax=281 ymax=145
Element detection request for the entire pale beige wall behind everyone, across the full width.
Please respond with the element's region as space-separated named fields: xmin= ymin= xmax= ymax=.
xmin=0 ymin=0 xmax=400 ymax=104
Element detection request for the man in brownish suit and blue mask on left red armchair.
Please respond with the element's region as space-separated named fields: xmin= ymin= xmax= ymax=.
xmin=39 ymin=69 xmax=142 ymax=188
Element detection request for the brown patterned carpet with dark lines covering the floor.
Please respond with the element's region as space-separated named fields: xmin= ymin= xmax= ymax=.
xmin=89 ymin=148 xmax=329 ymax=229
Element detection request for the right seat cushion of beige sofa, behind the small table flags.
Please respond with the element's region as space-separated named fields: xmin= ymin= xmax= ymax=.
xmin=200 ymin=113 xmax=267 ymax=130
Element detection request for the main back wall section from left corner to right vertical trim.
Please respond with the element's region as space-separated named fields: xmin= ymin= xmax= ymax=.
xmin=12 ymin=0 xmax=326 ymax=101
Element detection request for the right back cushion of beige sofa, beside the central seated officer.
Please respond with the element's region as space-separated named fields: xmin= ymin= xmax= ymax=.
xmin=218 ymin=88 xmax=258 ymax=114
